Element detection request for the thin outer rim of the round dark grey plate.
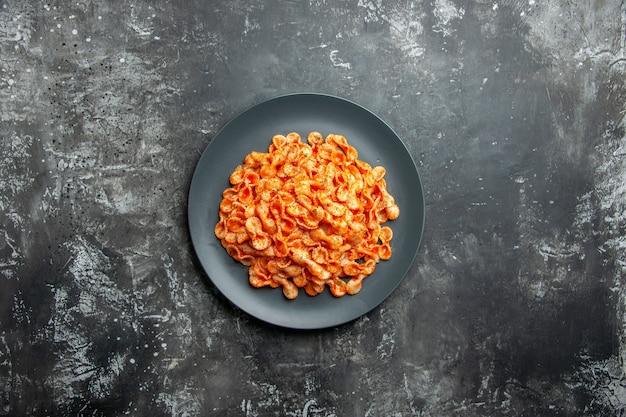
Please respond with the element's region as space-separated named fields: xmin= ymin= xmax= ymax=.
xmin=187 ymin=92 xmax=426 ymax=330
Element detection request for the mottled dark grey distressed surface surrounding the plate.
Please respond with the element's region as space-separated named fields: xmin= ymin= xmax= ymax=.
xmin=0 ymin=0 xmax=626 ymax=416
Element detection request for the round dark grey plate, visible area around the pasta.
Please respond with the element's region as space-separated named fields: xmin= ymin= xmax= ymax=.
xmin=188 ymin=94 xmax=424 ymax=329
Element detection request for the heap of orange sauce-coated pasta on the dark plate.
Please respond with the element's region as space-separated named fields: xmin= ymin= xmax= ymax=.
xmin=215 ymin=132 xmax=400 ymax=299
